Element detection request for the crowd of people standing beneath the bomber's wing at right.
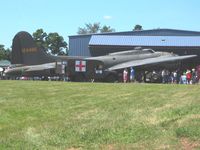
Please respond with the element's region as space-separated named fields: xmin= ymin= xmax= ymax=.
xmin=123 ymin=65 xmax=200 ymax=84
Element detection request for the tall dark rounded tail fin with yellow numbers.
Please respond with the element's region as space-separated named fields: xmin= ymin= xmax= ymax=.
xmin=11 ymin=31 xmax=55 ymax=65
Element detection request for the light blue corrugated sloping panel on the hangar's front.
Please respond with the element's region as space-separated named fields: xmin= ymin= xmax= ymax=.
xmin=89 ymin=35 xmax=200 ymax=47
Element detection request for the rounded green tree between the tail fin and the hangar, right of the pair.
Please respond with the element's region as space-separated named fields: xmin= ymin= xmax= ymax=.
xmin=46 ymin=32 xmax=68 ymax=55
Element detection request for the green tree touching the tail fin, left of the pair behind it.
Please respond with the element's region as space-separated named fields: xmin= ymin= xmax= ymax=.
xmin=33 ymin=29 xmax=48 ymax=52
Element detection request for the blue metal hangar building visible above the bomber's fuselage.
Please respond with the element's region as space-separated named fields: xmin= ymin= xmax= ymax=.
xmin=69 ymin=29 xmax=200 ymax=56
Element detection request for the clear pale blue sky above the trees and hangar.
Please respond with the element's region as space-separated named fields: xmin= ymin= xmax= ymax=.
xmin=0 ymin=0 xmax=200 ymax=48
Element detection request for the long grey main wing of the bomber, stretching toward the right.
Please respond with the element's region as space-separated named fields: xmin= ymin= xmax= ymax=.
xmin=108 ymin=55 xmax=197 ymax=71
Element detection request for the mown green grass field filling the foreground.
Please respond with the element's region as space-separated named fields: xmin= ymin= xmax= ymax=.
xmin=0 ymin=81 xmax=200 ymax=150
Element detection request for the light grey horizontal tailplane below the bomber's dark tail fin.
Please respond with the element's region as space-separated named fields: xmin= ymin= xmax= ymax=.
xmin=25 ymin=63 xmax=56 ymax=72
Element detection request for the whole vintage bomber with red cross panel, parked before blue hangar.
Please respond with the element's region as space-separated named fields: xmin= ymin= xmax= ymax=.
xmin=4 ymin=31 xmax=197 ymax=82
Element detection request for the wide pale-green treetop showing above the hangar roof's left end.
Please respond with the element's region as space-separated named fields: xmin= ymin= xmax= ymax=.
xmin=77 ymin=22 xmax=115 ymax=34
